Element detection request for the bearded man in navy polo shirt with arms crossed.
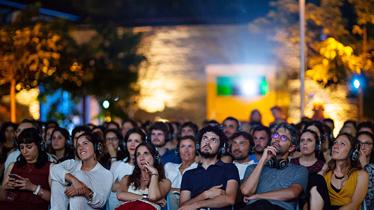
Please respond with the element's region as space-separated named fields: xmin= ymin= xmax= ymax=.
xmin=180 ymin=126 xmax=239 ymax=210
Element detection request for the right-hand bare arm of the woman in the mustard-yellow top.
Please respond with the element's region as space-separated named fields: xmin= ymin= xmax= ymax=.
xmin=340 ymin=170 xmax=369 ymax=210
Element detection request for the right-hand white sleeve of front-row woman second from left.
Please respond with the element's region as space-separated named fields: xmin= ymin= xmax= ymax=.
xmin=88 ymin=171 xmax=113 ymax=209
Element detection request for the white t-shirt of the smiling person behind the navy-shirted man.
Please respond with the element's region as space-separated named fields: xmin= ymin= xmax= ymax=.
xmin=164 ymin=162 xmax=197 ymax=188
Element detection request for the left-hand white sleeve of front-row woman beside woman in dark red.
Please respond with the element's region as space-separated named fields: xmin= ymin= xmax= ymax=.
xmin=49 ymin=160 xmax=76 ymax=185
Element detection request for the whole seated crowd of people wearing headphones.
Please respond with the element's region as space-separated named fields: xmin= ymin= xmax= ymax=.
xmin=0 ymin=107 xmax=374 ymax=210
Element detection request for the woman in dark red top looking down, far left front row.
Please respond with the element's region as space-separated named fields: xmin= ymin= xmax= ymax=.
xmin=0 ymin=128 xmax=51 ymax=210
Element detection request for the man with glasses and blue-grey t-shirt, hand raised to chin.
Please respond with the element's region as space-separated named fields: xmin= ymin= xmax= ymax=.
xmin=240 ymin=123 xmax=308 ymax=210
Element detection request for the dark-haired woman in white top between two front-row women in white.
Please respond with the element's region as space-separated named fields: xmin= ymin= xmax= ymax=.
xmin=107 ymin=128 xmax=145 ymax=210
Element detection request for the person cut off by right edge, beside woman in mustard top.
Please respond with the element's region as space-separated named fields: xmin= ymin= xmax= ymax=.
xmin=357 ymin=131 xmax=374 ymax=210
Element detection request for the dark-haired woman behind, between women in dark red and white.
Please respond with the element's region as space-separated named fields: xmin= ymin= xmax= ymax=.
xmin=50 ymin=127 xmax=74 ymax=163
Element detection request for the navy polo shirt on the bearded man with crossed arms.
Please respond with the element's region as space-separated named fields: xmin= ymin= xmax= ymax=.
xmin=181 ymin=160 xmax=240 ymax=210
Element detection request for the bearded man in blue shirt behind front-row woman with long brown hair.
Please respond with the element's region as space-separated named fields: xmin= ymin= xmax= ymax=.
xmin=150 ymin=122 xmax=182 ymax=165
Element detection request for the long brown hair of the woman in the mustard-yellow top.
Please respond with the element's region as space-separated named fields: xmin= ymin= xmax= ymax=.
xmin=327 ymin=133 xmax=362 ymax=176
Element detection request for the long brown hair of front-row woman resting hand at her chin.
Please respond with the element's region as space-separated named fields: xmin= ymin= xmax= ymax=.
xmin=127 ymin=142 xmax=165 ymax=189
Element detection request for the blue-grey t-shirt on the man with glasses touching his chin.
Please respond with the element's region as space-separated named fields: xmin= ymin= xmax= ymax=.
xmin=244 ymin=163 xmax=308 ymax=210
